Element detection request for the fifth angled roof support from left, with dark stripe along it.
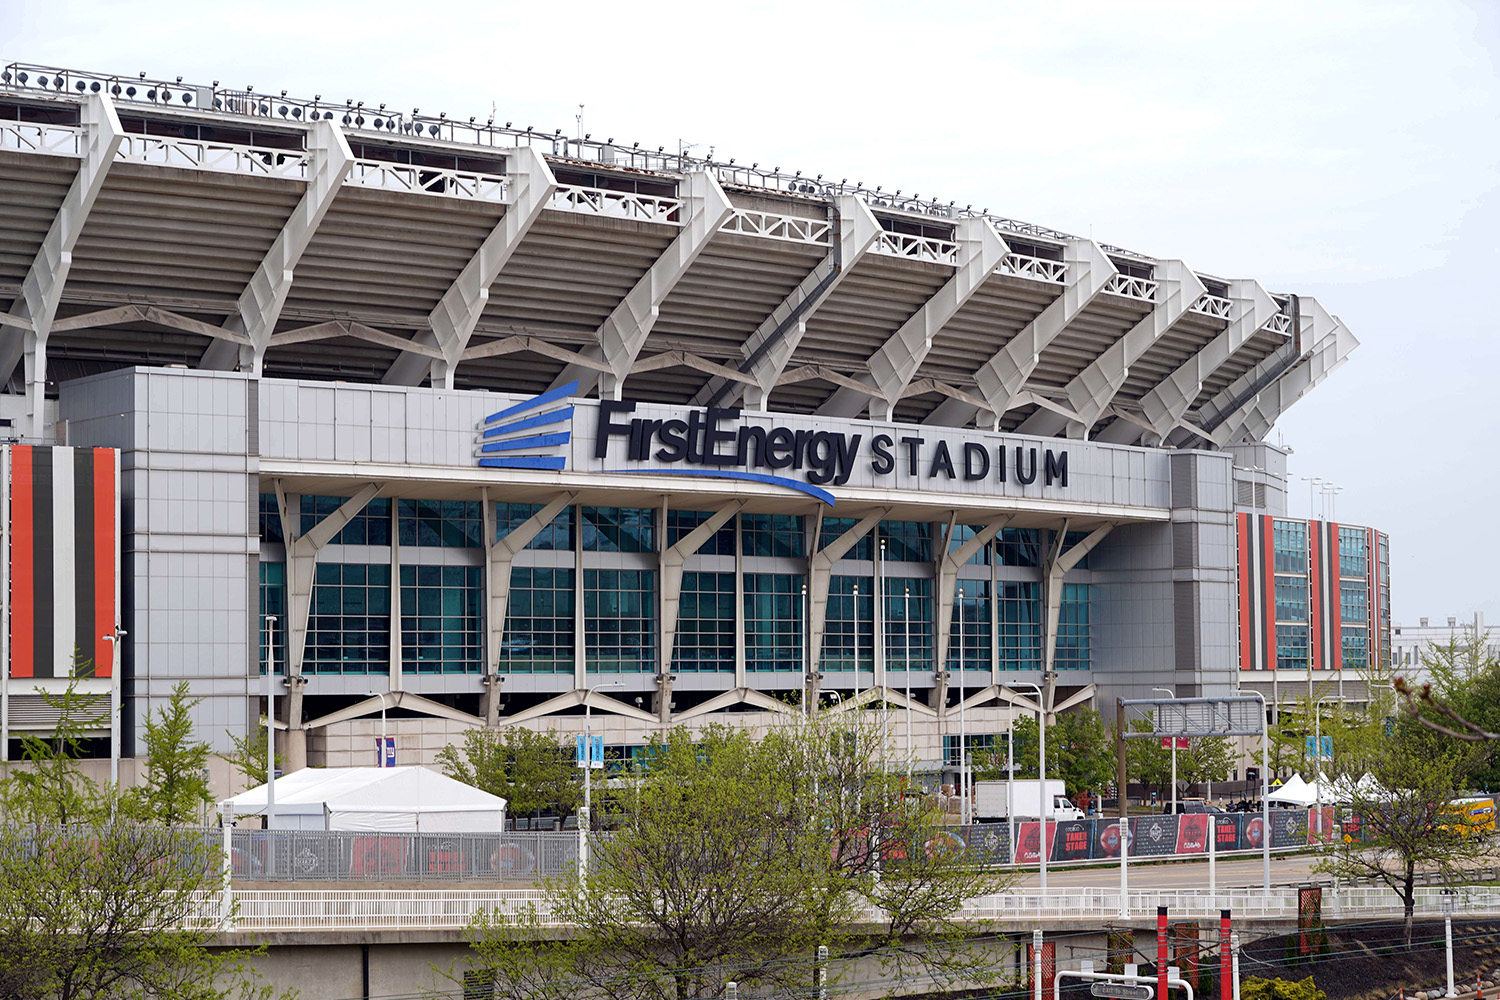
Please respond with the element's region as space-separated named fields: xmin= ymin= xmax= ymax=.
xmin=693 ymin=195 xmax=881 ymax=411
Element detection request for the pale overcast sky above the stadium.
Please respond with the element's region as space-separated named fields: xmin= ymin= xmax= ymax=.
xmin=0 ymin=0 xmax=1500 ymax=624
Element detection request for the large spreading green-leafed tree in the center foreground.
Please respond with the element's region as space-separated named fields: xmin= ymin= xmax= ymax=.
xmin=456 ymin=714 xmax=1008 ymax=1000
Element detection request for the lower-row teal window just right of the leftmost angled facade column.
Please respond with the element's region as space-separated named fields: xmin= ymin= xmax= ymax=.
xmin=303 ymin=562 xmax=390 ymax=673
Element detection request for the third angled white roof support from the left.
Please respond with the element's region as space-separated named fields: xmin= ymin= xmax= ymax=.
xmin=381 ymin=145 xmax=558 ymax=388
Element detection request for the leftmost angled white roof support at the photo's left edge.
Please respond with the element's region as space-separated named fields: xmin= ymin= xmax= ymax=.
xmin=0 ymin=93 xmax=125 ymax=435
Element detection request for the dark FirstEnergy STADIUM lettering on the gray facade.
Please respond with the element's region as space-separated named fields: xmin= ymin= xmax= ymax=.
xmin=594 ymin=399 xmax=1068 ymax=504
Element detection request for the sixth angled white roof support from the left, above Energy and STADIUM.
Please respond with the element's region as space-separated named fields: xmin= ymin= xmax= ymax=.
xmin=818 ymin=219 xmax=1010 ymax=420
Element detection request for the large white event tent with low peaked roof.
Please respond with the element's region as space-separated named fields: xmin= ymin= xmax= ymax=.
xmin=227 ymin=768 xmax=506 ymax=834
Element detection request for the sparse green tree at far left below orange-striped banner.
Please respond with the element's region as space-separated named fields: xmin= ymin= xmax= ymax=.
xmin=0 ymin=671 xmax=110 ymax=825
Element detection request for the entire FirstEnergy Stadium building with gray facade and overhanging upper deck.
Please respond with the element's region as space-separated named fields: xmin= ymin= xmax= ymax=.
xmin=0 ymin=64 xmax=1389 ymax=791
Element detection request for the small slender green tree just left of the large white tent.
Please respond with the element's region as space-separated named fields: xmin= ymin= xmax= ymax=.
xmin=126 ymin=681 xmax=213 ymax=826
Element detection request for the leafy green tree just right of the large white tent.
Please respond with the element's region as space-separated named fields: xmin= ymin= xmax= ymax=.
xmin=438 ymin=726 xmax=584 ymax=816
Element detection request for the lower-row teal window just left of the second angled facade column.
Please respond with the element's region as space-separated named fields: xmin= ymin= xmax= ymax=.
xmin=401 ymin=565 xmax=485 ymax=673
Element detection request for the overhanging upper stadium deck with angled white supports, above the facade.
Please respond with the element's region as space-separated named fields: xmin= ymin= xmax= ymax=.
xmin=0 ymin=63 xmax=1358 ymax=447
